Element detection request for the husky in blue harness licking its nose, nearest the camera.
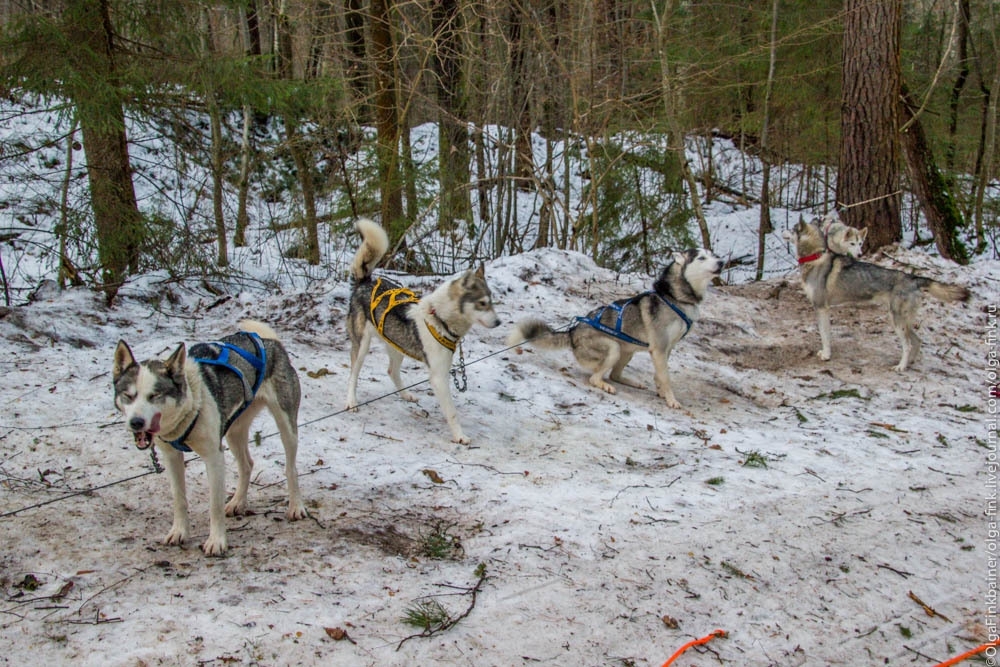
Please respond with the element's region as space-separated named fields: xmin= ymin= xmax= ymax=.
xmin=112 ymin=320 xmax=306 ymax=556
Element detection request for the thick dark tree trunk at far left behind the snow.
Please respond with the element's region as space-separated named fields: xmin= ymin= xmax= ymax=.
xmin=63 ymin=0 xmax=142 ymax=303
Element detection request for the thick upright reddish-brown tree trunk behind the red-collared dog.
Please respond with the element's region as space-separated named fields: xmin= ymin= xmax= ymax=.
xmin=837 ymin=0 xmax=902 ymax=249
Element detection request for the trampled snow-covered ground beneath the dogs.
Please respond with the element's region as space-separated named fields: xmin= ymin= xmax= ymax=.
xmin=0 ymin=228 xmax=998 ymax=667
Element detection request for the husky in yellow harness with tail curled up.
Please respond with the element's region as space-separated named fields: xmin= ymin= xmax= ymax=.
xmin=347 ymin=219 xmax=500 ymax=444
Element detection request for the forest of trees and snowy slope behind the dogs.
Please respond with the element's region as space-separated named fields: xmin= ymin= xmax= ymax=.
xmin=0 ymin=0 xmax=1000 ymax=305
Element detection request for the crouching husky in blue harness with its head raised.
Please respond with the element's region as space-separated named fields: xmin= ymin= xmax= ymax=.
xmin=507 ymin=249 xmax=723 ymax=408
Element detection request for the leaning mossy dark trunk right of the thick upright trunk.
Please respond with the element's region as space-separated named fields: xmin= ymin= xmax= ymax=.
xmin=899 ymin=89 xmax=969 ymax=264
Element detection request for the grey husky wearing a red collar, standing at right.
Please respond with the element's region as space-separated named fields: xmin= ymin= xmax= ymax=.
xmin=784 ymin=221 xmax=969 ymax=371
